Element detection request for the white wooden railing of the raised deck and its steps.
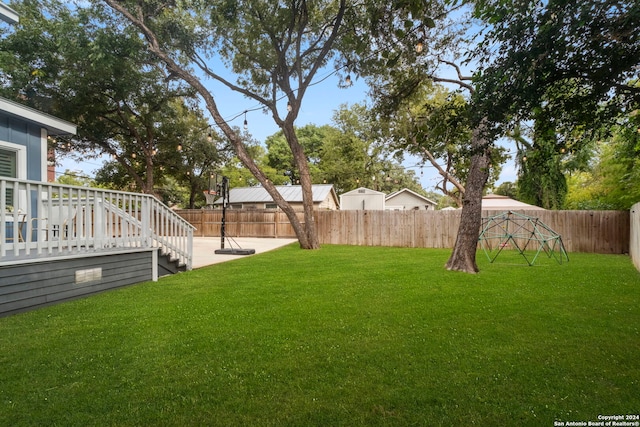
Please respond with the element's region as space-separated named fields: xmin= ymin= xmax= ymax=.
xmin=0 ymin=177 xmax=194 ymax=270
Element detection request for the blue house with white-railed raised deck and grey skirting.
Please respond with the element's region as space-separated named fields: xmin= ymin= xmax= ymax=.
xmin=0 ymin=2 xmax=193 ymax=316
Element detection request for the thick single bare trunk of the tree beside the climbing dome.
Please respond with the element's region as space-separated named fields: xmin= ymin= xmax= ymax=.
xmin=446 ymin=124 xmax=491 ymax=273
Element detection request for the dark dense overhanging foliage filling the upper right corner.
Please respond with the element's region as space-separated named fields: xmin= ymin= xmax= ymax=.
xmin=474 ymin=0 xmax=640 ymax=135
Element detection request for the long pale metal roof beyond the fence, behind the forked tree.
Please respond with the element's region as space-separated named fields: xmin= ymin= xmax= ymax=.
xmin=214 ymin=184 xmax=338 ymax=205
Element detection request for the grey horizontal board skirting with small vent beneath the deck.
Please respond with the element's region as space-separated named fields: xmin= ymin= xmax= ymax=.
xmin=0 ymin=250 xmax=154 ymax=316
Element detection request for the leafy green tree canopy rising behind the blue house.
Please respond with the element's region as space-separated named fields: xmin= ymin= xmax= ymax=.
xmin=0 ymin=0 xmax=228 ymax=194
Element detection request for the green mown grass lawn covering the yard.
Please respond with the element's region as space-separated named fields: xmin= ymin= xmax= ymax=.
xmin=0 ymin=245 xmax=640 ymax=426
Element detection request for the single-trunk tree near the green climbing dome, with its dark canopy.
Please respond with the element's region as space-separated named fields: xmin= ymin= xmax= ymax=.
xmin=350 ymin=0 xmax=640 ymax=272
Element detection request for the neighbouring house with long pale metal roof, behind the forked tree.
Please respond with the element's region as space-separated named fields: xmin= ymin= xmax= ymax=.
xmin=213 ymin=184 xmax=338 ymax=210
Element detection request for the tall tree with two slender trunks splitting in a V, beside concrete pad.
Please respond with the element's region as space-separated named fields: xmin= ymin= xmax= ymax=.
xmin=105 ymin=0 xmax=352 ymax=249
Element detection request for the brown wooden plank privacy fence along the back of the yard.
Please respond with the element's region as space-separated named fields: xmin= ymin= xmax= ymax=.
xmin=177 ymin=209 xmax=630 ymax=254
